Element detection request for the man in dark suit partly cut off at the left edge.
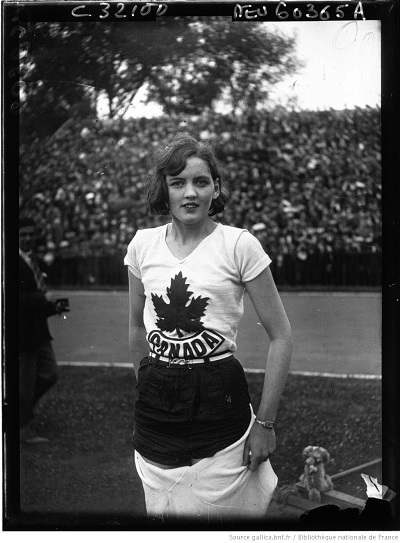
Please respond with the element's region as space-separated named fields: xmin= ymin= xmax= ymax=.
xmin=19 ymin=217 xmax=63 ymax=444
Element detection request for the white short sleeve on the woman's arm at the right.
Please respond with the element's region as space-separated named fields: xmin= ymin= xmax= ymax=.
xmin=235 ymin=230 xmax=271 ymax=283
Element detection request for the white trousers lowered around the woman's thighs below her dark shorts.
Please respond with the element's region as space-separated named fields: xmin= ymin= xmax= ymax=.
xmin=135 ymin=416 xmax=278 ymax=521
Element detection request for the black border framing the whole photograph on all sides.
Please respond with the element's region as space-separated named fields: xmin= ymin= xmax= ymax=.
xmin=1 ymin=0 xmax=400 ymax=531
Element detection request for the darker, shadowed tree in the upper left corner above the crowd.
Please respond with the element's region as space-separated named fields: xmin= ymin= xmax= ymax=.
xmin=21 ymin=19 xmax=192 ymax=139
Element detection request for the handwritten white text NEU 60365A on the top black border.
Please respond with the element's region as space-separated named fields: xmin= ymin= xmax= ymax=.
xmin=233 ymin=2 xmax=365 ymax=21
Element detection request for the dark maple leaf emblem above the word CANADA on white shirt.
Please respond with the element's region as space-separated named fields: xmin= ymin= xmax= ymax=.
xmin=151 ymin=272 xmax=209 ymax=337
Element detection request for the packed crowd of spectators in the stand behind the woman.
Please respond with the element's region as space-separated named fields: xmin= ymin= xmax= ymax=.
xmin=20 ymin=108 xmax=381 ymax=282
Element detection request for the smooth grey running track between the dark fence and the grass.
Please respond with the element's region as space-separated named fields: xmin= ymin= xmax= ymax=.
xmin=49 ymin=291 xmax=381 ymax=378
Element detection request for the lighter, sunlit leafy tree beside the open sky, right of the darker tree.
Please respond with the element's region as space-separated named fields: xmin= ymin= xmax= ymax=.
xmin=145 ymin=17 xmax=299 ymax=114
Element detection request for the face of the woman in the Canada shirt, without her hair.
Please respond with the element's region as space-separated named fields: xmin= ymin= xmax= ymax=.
xmin=166 ymin=157 xmax=219 ymax=224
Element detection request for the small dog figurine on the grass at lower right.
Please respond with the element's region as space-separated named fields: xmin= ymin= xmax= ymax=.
xmin=300 ymin=446 xmax=333 ymax=502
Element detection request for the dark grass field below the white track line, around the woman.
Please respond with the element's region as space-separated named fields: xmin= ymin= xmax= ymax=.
xmin=21 ymin=367 xmax=381 ymax=525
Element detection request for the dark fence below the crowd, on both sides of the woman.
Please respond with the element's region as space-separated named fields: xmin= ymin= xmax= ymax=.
xmin=48 ymin=252 xmax=382 ymax=288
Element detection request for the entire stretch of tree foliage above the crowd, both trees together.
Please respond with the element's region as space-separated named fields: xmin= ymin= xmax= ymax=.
xmin=21 ymin=17 xmax=294 ymax=140
